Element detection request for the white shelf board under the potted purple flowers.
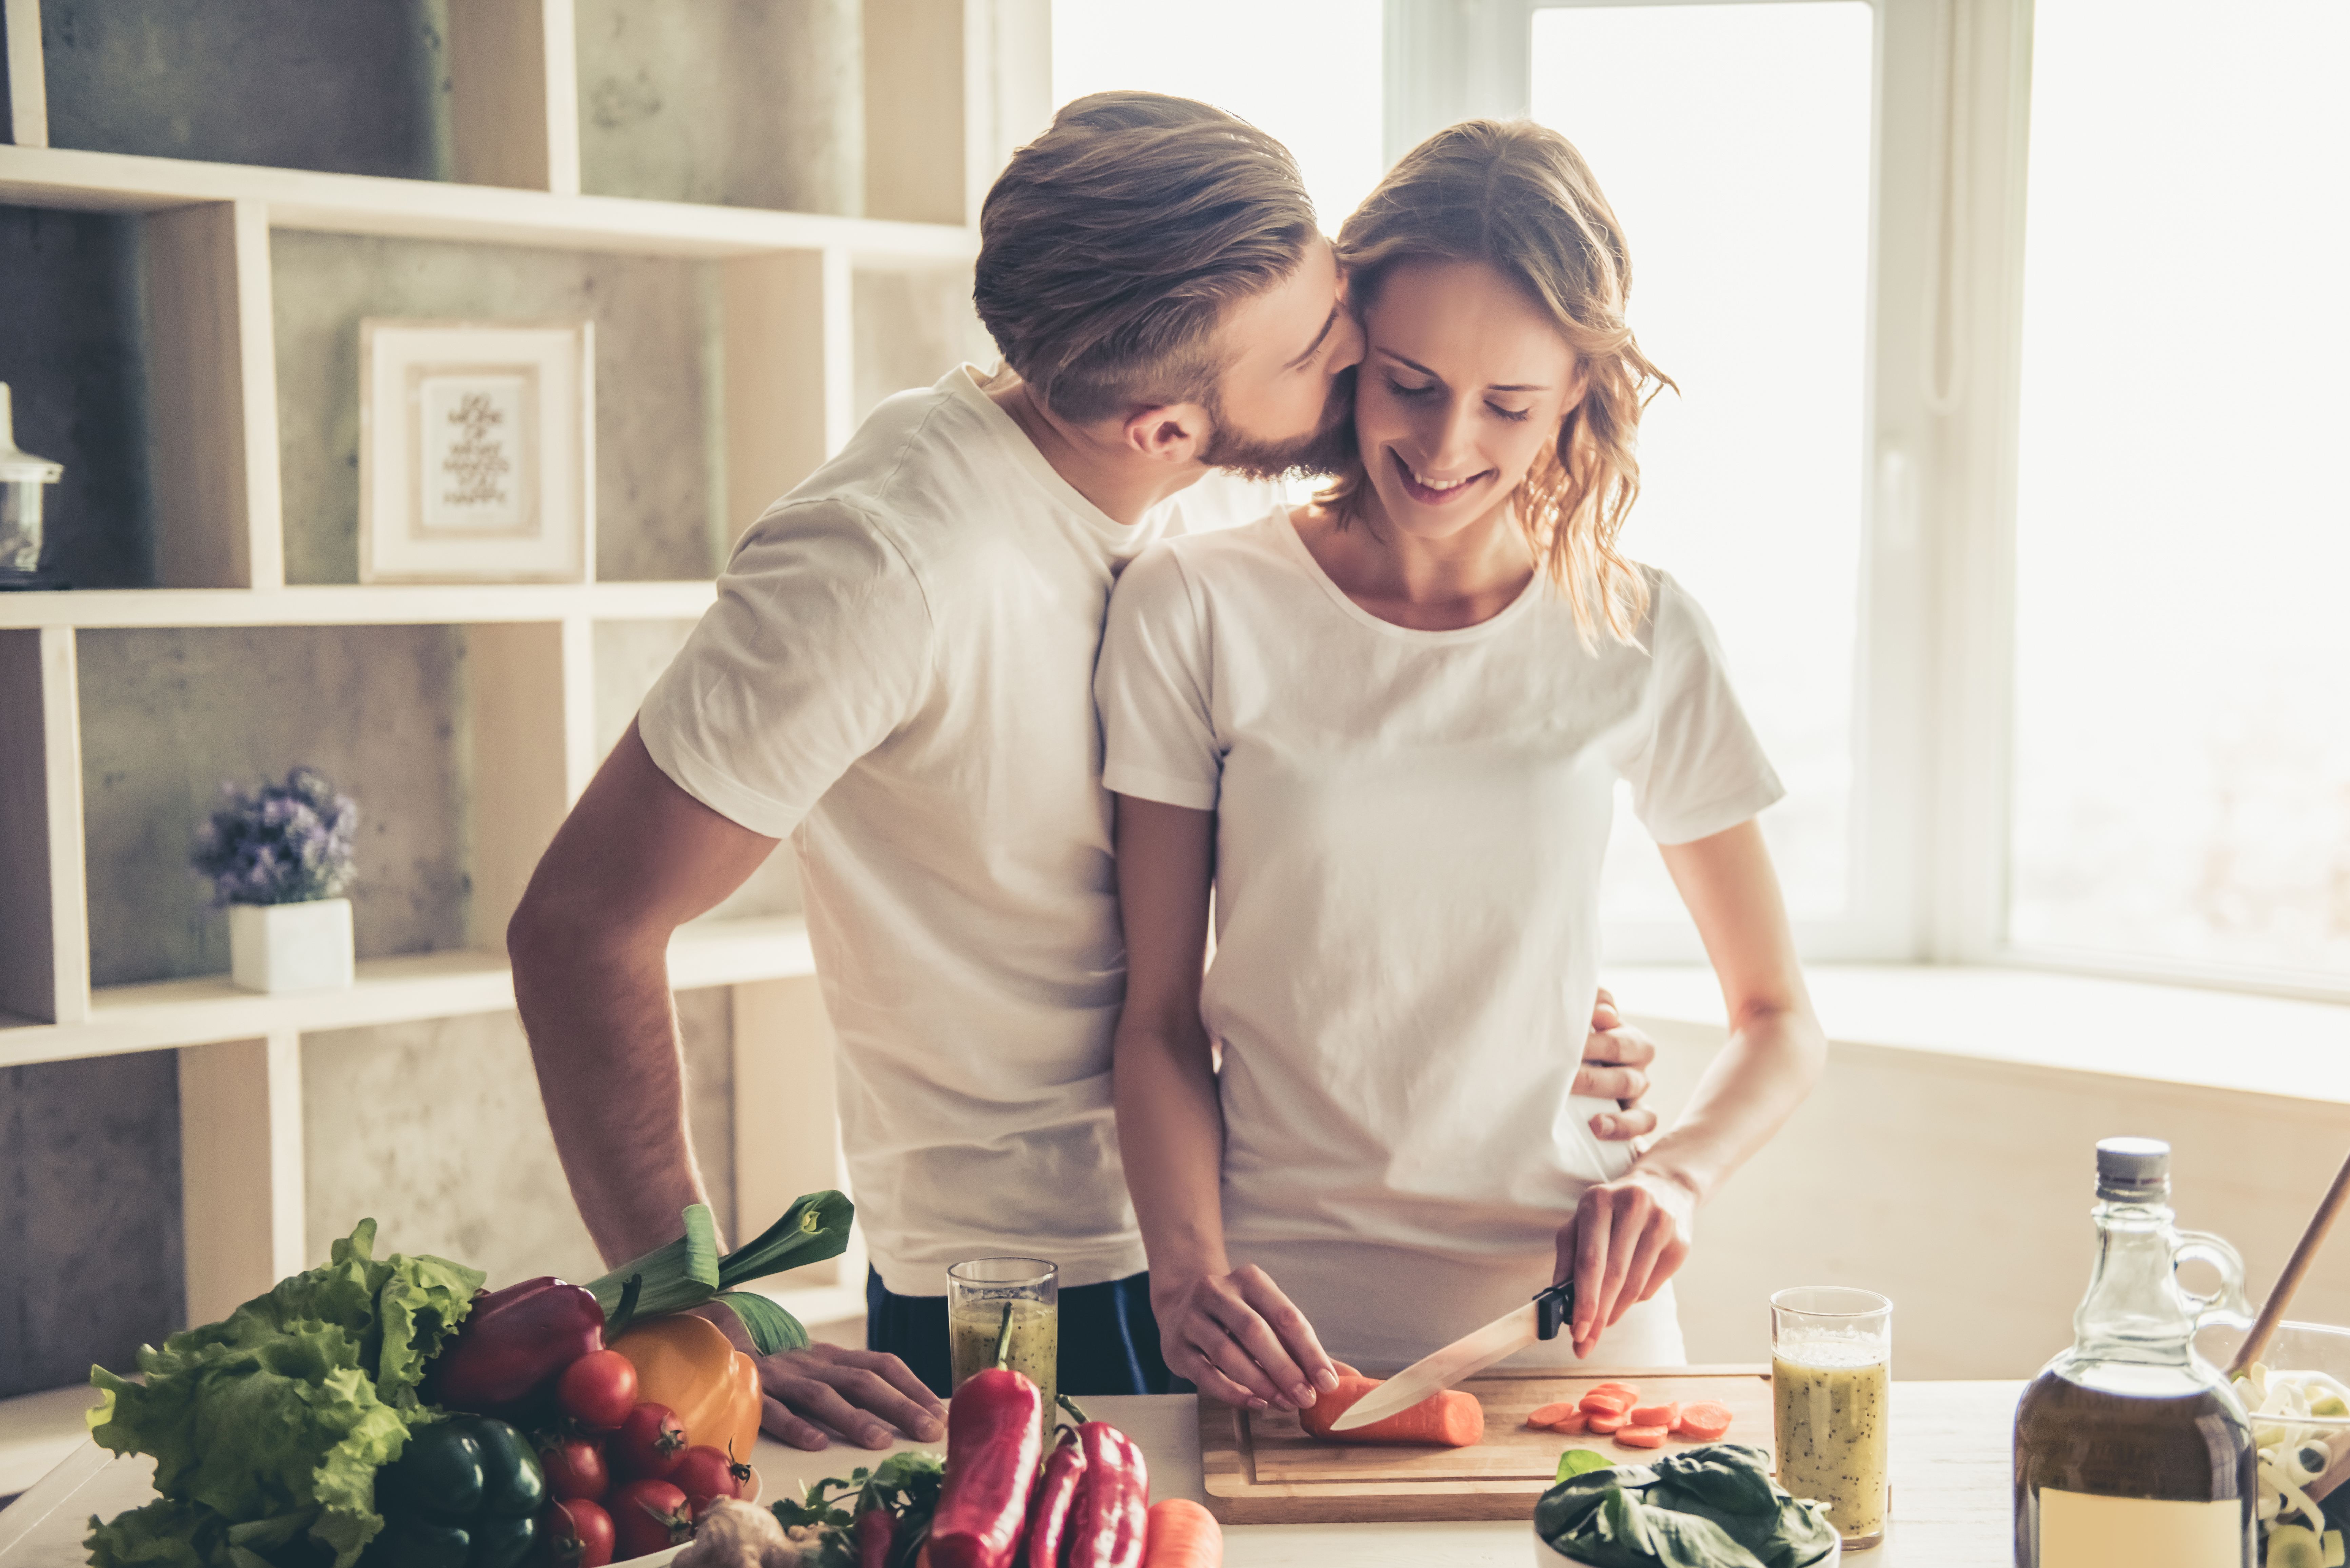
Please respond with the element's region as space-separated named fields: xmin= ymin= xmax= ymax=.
xmin=0 ymin=917 xmax=815 ymax=1067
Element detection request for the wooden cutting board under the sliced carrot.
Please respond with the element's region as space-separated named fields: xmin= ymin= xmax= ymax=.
xmin=1199 ymin=1366 xmax=1772 ymax=1523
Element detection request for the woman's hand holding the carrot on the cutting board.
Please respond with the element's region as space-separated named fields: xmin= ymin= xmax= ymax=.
xmin=1151 ymin=1262 xmax=1337 ymax=1410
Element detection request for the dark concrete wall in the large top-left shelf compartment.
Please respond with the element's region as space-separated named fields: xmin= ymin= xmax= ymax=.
xmin=40 ymin=0 xmax=449 ymax=179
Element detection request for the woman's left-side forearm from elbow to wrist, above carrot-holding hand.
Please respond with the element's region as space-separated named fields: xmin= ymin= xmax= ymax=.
xmin=1116 ymin=1027 xmax=1231 ymax=1276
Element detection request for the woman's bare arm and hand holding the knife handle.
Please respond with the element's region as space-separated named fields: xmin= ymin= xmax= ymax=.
xmin=1553 ymin=821 xmax=1828 ymax=1354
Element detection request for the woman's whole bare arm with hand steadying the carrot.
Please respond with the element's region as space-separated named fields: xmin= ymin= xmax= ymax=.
xmin=1114 ymin=795 xmax=1337 ymax=1410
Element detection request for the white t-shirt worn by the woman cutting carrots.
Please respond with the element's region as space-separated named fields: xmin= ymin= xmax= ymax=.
xmin=1095 ymin=510 xmax=1781 ymax=1370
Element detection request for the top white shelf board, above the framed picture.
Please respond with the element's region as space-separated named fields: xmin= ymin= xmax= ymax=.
xmin=0 ymin=146 xmax=977 ymax=266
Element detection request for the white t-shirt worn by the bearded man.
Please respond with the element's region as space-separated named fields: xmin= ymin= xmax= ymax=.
xmin=637 ymin=369 xmax=1267 ymax=1295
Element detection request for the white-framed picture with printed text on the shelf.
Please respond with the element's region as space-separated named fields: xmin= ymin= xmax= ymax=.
xmin=359 ymin=320 xmax=595 ymax=583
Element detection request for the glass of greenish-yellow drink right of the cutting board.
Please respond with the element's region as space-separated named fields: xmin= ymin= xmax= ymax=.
xmin=1770 ymin=1286 xmax=1894 ymax=1551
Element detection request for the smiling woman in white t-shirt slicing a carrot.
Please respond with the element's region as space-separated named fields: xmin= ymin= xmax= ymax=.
xmin=1098 ymin=122 xmax=1826 ymax=1408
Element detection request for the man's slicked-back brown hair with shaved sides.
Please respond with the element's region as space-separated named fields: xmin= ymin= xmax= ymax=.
xmin=971 ymin=92 xmax=1321 ymax=423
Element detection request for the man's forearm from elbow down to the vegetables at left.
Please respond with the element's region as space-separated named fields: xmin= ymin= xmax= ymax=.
xmin=512 ymin=933 xmax=710 ymax=1267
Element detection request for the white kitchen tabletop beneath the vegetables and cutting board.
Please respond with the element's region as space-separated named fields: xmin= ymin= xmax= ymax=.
xmin=0 ymin=1382 xmax=2023 ymax=1568
